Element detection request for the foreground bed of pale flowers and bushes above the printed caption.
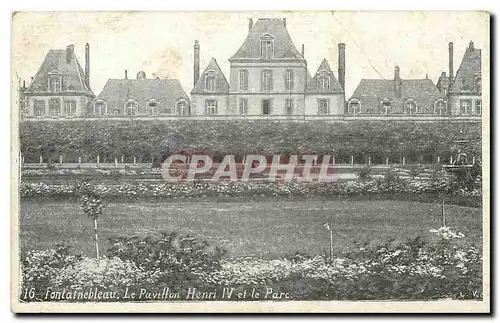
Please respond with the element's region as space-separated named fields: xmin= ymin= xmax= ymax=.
xmin=20 ymin=228 xmax=482 ymax=301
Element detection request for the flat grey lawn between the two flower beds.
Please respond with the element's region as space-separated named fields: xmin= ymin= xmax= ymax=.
xmin=20 ymin=199 xmax=482 ymax=258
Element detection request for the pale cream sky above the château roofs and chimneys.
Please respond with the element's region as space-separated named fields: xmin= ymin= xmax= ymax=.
xmin=12 ymin=11 xmax=489 ymax=97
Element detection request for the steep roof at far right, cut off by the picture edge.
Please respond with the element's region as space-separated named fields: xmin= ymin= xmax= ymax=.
xmin=451 ymin=42 xmax=481 ymax=93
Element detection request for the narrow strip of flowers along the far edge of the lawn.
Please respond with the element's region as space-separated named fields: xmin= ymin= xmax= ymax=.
xmin=20 ymin=178 xmax=481 ymax=204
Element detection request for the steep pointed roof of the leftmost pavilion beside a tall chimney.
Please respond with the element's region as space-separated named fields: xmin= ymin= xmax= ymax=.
xmin=26 ymin=49 xmax=94 ymax=96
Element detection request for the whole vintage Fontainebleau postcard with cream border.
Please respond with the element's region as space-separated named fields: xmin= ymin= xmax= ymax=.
xmin=11 ymin=11 xmax=490 ymax=313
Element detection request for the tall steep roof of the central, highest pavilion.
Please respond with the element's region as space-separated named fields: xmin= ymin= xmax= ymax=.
xmin=229 ymin=18 xmax=304 ymax=61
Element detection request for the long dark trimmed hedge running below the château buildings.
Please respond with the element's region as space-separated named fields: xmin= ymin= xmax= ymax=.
xmin=20 ymin=120 xmax=481 ymax=164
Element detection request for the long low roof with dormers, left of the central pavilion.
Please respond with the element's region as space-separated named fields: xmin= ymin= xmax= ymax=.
xmin=96 ymin=78 xmax=189 ymax=109
